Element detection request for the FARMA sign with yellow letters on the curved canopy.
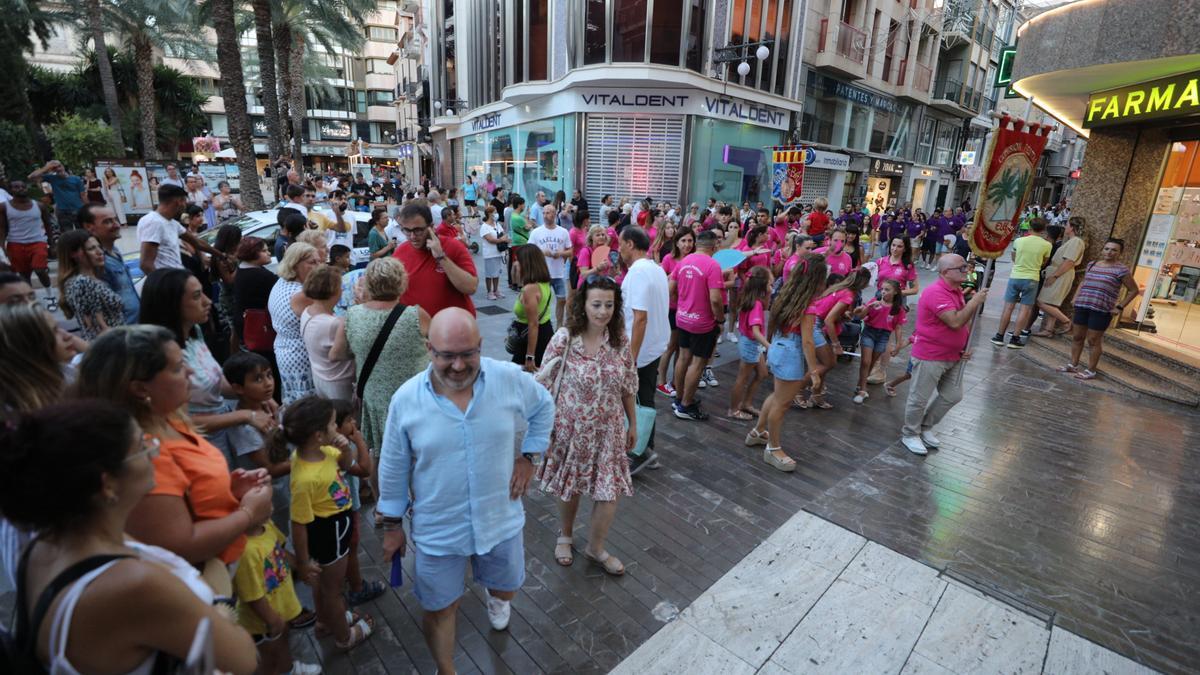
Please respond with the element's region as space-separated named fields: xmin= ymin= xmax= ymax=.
xmin=1084 ymin=72 xmax=1200 ymax=129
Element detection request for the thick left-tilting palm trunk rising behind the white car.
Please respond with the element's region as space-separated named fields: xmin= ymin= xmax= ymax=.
xmin=208 ymin=0 xmax=263 ymax=210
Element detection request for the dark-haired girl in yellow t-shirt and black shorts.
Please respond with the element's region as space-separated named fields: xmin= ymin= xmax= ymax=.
xmin=268 ymin=395 xmax=372 ymax=650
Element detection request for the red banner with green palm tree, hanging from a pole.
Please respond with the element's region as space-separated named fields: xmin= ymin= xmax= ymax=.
xmin=965 ymin=115 xmax=1054 ymax=258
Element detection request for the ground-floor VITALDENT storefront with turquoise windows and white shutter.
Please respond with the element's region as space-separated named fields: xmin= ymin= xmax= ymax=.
xmin=443 ymin=88 xmax=791 ymax=204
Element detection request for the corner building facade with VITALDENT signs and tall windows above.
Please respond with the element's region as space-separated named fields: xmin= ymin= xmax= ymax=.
xmin=428 ymin=0 xmax=805 ymax=208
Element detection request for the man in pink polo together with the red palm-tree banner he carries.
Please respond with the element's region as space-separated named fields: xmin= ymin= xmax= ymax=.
xmin=900 ymin=115 xmax=1050 ymax=455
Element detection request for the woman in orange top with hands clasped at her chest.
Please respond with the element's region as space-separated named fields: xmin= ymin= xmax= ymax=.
xmin=77 ymin=324 xmax=271 ymax=565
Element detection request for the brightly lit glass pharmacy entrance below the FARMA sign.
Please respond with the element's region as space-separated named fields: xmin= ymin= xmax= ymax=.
xmin=1134 ymin=141 xmax=1200 ymax=362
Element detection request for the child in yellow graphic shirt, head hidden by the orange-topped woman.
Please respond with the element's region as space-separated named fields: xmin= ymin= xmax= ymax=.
xmin=233 ymin=520 xmax=320 ymax=675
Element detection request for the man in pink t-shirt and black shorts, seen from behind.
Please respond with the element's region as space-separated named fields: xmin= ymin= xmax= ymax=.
xmin=671 ymin=231 xmax=725 ymax=422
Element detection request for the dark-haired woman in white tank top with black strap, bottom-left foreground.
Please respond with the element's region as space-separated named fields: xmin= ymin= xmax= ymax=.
xmin=0 ymin=400 xmax=256 ymax=674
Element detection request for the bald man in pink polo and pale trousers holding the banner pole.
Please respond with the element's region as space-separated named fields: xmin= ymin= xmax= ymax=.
xmin=900 ymin=253 xmax=988 ymax=455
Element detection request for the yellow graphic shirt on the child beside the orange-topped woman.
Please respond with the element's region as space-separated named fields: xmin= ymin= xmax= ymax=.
xmin=233 ymin=520 xmax=300 ymax=635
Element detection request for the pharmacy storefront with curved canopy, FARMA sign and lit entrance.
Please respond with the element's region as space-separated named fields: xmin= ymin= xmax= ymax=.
xmin=1013 ymin=0 xmax=1200 ymax=364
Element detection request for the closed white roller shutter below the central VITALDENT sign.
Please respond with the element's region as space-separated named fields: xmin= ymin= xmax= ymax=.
xmin=586 ymin=114 xmax=684 ymax=204
